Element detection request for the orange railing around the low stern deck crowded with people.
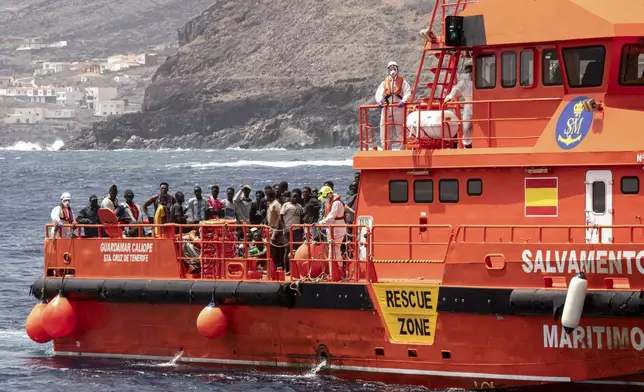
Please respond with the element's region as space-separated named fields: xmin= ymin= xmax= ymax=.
xmin=46 ymin=222 xmax=376 ymax=282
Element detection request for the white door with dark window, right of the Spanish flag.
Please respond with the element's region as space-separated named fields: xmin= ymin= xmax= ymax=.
xmin=586 ymin=170 xmax=613 ymax=244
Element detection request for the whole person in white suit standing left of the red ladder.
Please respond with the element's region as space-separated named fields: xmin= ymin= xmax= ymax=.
xmin=376 ymin=61 xmax=411 ymax=150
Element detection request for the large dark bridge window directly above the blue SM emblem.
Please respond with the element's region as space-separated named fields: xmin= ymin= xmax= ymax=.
xmin=563 ymin=46 xmax=606 ymax=87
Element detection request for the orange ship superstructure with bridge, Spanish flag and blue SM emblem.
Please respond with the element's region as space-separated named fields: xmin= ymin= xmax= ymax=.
xmin=354 ymin=0 xmax=644 ymax=283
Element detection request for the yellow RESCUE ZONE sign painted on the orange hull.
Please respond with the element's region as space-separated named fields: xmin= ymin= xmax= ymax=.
xmin=373 ymin=283 xmax=439 ymax=344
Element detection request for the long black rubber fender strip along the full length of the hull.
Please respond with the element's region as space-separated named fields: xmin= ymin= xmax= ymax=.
xmin=31 ymin=278 xmax=644 ymax=318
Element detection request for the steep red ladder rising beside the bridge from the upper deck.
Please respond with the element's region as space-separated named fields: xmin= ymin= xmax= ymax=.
xmin=412 ymin=0 xmax=478 ymax=107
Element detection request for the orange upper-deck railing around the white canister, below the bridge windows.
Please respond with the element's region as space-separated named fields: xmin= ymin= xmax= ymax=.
xmin=359 ymin=98 xmax=561 ymax=151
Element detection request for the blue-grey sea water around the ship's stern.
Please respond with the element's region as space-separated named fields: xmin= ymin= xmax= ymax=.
xmin=0 ymin=148 xmax=432 ymax=392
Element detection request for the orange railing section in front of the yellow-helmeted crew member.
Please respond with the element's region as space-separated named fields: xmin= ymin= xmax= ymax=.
xmin=288 ymin=224 xmax=377 ymax=282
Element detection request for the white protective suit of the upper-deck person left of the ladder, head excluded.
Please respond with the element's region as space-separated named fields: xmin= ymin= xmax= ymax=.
xmin=376 ymin=73 xmax=411 ymax=149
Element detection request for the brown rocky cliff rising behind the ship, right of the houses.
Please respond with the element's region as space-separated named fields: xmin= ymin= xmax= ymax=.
xmin=67 ymin=0 xmax=432 ymax=148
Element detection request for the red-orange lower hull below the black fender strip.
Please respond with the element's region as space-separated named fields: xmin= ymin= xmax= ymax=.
xmin=45 ymin=301 xmax=644 ymax=390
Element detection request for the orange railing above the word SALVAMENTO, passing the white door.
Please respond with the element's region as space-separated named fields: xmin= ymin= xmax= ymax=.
xmin=455 ymin=225 xmax=644 ymax=245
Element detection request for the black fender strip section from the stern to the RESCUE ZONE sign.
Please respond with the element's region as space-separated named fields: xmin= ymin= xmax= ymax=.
xmin=31 ymin=278 xmax=373 ymax=310
